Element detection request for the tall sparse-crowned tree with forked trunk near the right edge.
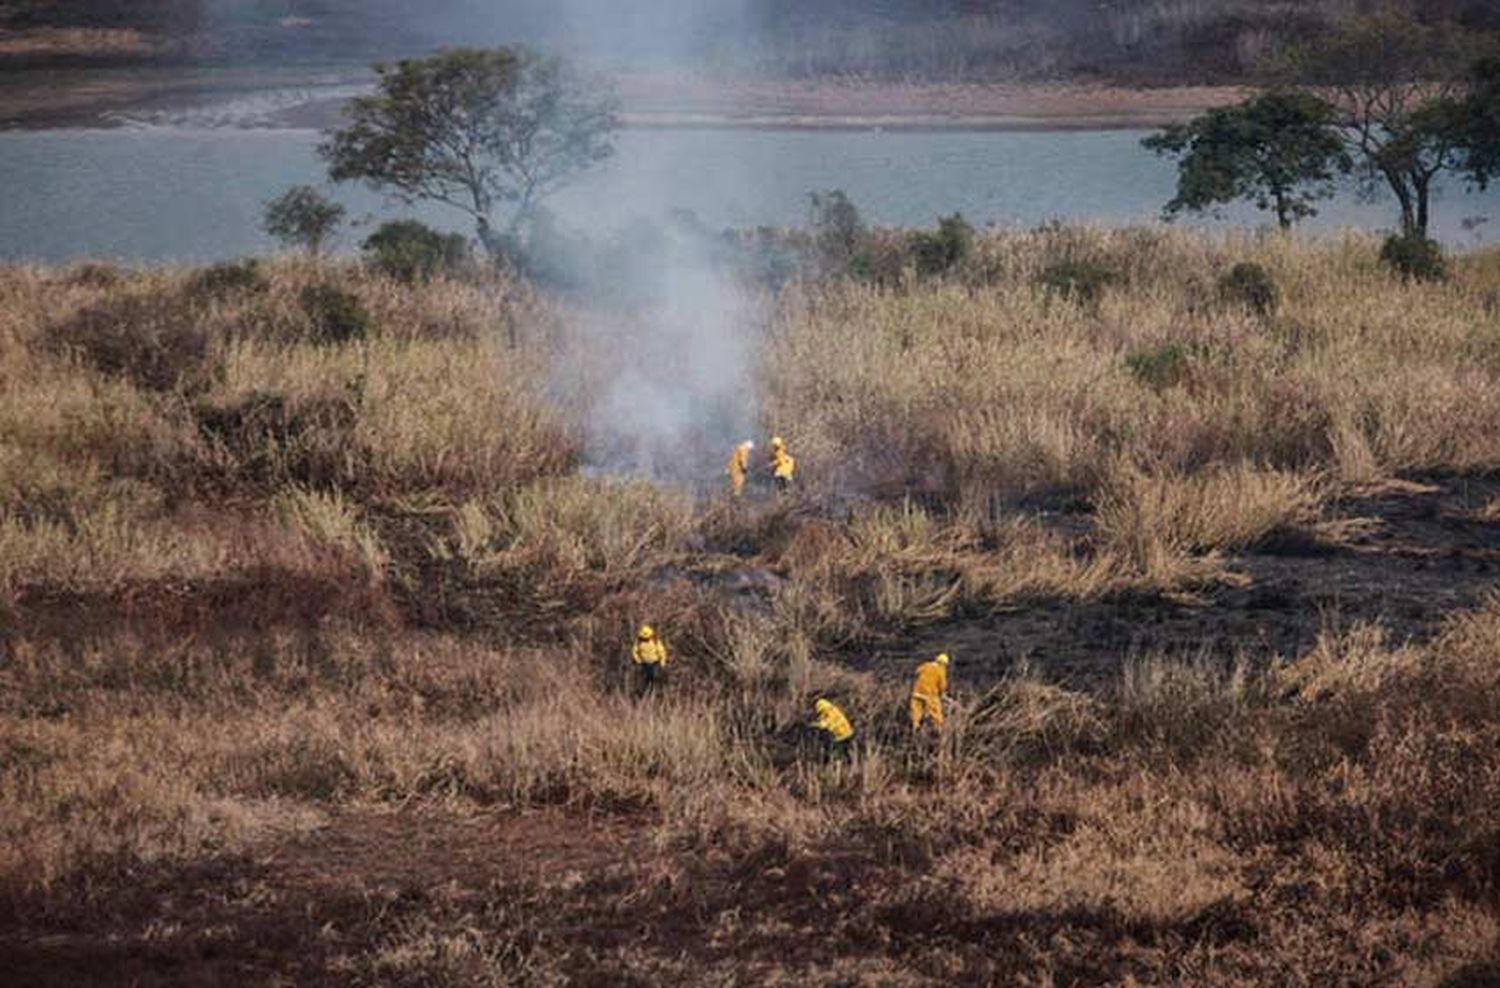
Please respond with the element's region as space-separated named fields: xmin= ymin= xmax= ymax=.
xmin=1281 ymin=13 xmax=1484 ymax=238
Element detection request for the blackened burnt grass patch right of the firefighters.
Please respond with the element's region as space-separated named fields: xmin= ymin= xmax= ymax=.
xmin=882 ymin=477 xmax=1500 ymax=687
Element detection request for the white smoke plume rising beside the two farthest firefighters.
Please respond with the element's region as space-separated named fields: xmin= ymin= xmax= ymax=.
xmin=531 ymin=0 xmax=762 ymax=486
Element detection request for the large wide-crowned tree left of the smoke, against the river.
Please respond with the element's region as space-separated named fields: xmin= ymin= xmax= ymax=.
xmin=320 ymin=48 xmax=617 ymax=255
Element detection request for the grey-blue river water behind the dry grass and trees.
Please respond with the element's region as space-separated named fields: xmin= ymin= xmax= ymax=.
xmin=0 ymin=124 xmax=1500 ymax=262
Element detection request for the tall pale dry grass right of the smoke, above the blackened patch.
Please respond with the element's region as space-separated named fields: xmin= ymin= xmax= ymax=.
xmin=767 ymin=231 xmax=1500 ymax=511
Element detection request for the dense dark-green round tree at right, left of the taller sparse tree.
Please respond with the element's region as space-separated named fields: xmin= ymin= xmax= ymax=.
xmin=1143 ymin=90 xmax=1352 ymax=229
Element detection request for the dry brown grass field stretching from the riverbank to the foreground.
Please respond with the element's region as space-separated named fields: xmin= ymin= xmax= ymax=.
xmin=0 ymin=229 xmax=1500 ymax=988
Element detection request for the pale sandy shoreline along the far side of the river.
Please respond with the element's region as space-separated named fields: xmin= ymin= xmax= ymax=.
xmin=0 ymin=66 xmax=1241 ymax=130
